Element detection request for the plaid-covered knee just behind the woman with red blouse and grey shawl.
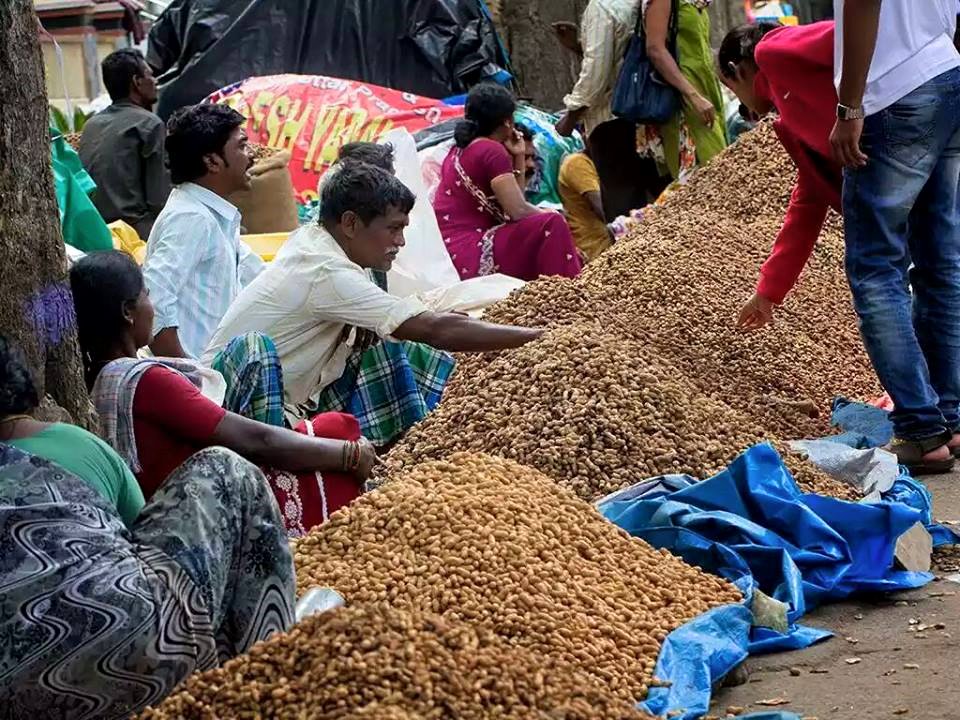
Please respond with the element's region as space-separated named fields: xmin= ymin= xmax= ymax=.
xmin=211 ymin=333 xmax=285 ymax=427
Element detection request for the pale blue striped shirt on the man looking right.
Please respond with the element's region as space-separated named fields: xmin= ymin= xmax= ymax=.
xmin=143 ymin=183 xmax=264 ymax=358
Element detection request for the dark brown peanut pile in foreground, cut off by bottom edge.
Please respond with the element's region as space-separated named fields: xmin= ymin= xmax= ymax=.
xmin=140 ymin=605 xmax=652 ymax=720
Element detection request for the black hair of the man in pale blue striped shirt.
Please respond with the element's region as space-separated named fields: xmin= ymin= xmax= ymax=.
xmin=166 ymin=103 xmax=246 ymax=185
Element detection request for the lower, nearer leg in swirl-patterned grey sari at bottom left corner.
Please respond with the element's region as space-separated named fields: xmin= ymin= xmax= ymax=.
xmin=0 ymin=443 xmax=218 ymax=718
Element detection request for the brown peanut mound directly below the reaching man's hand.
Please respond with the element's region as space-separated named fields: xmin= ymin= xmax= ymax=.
xmin=386 ymin=324 xmax=856 ymax=500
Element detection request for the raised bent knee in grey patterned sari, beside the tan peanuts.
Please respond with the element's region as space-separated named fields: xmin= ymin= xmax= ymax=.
xmin=132 ymin=448 xmax=296 ymax=661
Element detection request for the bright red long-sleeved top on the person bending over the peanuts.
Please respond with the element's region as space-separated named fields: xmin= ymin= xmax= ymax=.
xmin=754 ymin=22 xmax=843 ymax=304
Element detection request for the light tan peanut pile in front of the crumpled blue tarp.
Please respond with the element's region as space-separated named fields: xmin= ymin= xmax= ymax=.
xmin=294 ymin=453 xmax=740 ymax=701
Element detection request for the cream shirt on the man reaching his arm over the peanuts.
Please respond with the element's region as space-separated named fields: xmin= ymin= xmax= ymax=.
xmin=203 ymin=224 xmax=427 ymax=405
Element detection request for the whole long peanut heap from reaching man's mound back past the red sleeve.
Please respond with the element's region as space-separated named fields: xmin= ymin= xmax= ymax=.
xmin=387 ymin=119 xmax=881 ymax=500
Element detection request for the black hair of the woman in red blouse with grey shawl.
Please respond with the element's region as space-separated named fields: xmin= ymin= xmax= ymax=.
xmin=70 ymin=250 xmax=143 ymax=387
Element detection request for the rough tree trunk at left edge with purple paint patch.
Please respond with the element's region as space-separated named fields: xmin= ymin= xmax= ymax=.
xmin=0 ymin=0 xmax=95 ymax=427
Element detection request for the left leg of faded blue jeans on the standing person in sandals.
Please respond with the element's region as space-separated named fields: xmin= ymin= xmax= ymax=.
xmin=843 ymin=74 xmax=953 ymax=457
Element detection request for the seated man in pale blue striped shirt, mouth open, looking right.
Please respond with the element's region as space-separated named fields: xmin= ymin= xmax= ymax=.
xmin=143 ymin=104 xmax=263 ymax=358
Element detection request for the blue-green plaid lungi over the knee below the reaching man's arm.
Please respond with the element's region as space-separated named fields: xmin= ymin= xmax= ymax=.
xmin=317 ymin=341 xmax=454 ymax=447
